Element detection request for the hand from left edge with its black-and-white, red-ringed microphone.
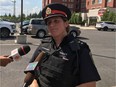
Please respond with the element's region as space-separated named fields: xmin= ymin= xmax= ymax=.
xmin=0 ymin=46 xmax=30 ymax=66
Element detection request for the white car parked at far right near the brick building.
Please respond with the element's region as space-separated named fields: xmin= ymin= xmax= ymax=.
xmin=95 ymin=21 xmax=116 ymax=31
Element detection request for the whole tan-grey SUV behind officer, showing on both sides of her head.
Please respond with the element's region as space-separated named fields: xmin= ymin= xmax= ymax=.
xmin=27 ymin=18 xmax=81 ymax=38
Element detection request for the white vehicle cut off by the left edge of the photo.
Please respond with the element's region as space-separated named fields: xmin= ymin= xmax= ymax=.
xmin=0 ymin=19 xmax=16 ymax=38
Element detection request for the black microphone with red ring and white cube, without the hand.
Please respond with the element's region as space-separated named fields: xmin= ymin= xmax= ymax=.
xmin=8 ymin=45 xmax=30 ymax=61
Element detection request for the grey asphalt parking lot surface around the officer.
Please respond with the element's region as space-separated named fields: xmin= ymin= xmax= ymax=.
xmin=0 ymin=29 xmax=116 ymax=87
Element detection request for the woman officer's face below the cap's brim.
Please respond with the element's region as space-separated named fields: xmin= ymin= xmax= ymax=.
xmin=47 ymin=17 xmax=69 ymax=37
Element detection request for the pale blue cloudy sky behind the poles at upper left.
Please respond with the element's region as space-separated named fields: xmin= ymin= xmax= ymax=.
xmin=0 ymin=0 xmax=42 ymax=16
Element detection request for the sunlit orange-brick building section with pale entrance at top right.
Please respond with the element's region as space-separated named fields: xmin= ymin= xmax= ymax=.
xmin=86 ymin=0 xmax=116 ymax=21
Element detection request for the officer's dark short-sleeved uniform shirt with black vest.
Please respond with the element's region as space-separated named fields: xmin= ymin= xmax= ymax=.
xmin=30 ymin=35 xmax=100 ymax=87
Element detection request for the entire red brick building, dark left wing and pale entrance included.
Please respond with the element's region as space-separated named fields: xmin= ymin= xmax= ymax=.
xmin=42 ymin=0 xmax=116 ymax=23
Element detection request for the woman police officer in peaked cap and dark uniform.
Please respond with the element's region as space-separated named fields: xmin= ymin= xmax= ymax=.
xmin=31 ymin=3 xmax=100 ymax=87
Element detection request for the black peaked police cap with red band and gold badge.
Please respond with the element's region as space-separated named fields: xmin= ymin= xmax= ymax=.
xmin=42 ymin=3 xmax=71 ymax=20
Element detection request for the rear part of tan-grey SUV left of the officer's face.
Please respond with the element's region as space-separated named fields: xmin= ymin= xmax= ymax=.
xmin=27 ymin=18 xmax=48 ymax=38
